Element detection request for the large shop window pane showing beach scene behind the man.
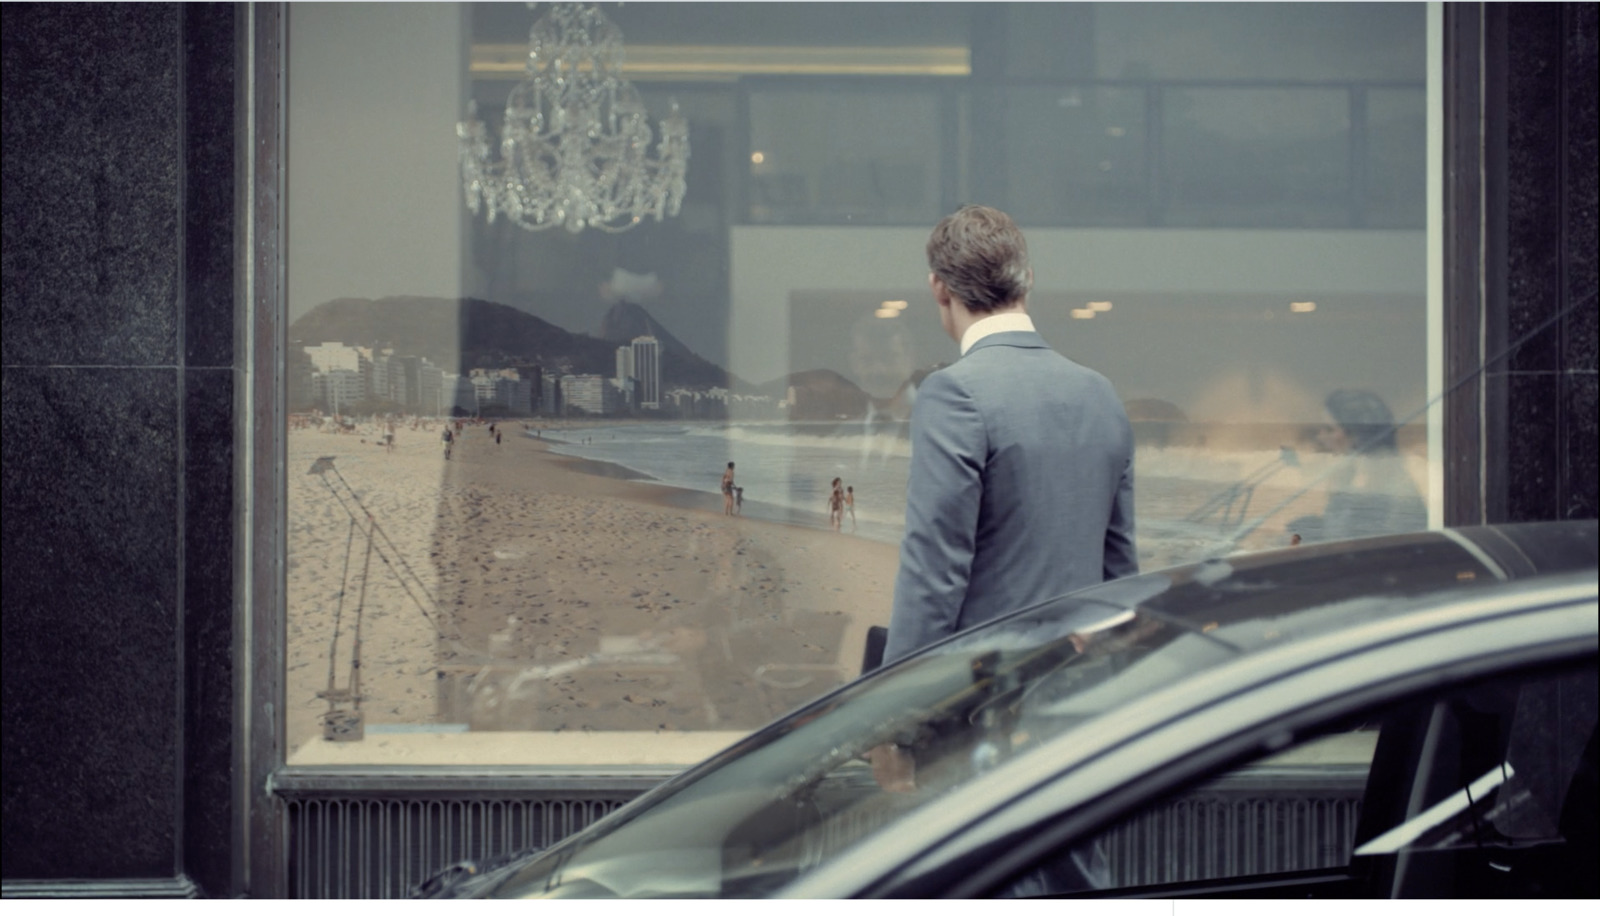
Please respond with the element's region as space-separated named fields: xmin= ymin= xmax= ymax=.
xmin=285 ymin=3 xmax=1438 ymax=765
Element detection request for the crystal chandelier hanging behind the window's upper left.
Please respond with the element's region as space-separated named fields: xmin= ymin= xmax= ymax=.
xmin=456 ymin=3 xmax=690 ymax=234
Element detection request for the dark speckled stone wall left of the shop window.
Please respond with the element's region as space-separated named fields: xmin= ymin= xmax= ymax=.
xmin=0 ymin=3 xmax=235 ymax=894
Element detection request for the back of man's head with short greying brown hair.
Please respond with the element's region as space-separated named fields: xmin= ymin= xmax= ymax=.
xmin=928 ymin=205 xmax=1032 ymax=312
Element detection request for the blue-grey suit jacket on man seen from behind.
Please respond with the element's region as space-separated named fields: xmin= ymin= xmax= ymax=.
xmin=883 ymin=331 xmax=1139 ymax=661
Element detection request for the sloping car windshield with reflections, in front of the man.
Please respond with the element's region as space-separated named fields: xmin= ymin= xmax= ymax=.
xmin=491 ymin=540 xmax=1523 ymax=898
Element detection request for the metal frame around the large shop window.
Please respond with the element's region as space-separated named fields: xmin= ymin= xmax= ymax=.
xmin=243 ymin=2 xmax=1507 ymax=897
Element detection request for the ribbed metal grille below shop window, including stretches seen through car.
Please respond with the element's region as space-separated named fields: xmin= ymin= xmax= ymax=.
xmin=280 ymin=775 xmax=1360 ymax=898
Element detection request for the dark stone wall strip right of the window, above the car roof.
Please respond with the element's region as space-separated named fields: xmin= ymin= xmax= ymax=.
xmin=1485 ymin=3 xmax=1600 ymax=520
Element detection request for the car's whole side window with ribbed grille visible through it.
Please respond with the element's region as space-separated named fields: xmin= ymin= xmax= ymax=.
xmin=997 ymin=666 xmax=1597 ymax=897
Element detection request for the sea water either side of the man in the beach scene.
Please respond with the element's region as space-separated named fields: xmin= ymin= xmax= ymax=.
xmin=530 ymin=420 xmax=1427 ymax=568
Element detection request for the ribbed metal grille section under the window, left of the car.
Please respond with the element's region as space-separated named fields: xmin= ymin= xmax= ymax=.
xmin=285 ymin=794 xmax=632 ymax=898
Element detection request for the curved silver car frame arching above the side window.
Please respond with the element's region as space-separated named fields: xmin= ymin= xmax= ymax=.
xmin=782 ymin=577 xmax=1600 ymax=897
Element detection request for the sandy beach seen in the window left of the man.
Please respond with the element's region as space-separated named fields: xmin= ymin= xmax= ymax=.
xmin=286 ymin=420 xmax=898 ymax=765
